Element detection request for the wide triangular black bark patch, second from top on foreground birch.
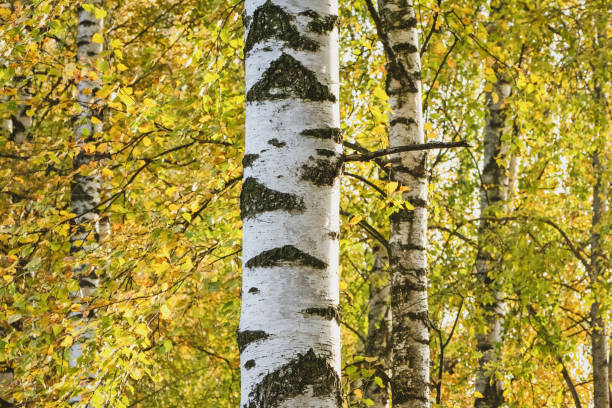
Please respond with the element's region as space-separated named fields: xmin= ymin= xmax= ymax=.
xmin=246 ymin=53 xmax=336 ymax=102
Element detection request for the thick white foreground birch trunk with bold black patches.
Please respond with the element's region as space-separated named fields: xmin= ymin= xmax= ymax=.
xmin=237 ymin=0 xmax=342 ymax=408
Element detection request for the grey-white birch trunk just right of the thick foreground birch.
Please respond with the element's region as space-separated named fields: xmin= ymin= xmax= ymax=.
xmin=379 ymin=0 xmax=430 ymax=408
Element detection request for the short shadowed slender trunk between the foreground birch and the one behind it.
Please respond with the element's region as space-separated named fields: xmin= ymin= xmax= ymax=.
xmin=364 ymin=246 xmax=391 ymax=408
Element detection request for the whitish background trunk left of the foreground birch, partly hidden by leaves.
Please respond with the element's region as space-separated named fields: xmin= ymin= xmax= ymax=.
xmin=69 ymin=1 xmax=103 ymax=404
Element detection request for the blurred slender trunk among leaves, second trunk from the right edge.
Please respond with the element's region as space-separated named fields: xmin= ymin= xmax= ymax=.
xmin=475 ymin=69 xmax=511 ymax=408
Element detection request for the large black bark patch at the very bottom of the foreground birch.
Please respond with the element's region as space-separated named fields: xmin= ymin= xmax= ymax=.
xmin=243 ymin=349 xmax=342 ymax=408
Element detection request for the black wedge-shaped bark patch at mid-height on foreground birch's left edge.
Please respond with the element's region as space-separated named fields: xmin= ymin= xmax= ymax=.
xmin=240 ymin=177 xmax=305 ymax=219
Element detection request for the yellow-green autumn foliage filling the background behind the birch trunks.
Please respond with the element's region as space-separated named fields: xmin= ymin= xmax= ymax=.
xmin=0 ymin=0 xmax=612 ymax=408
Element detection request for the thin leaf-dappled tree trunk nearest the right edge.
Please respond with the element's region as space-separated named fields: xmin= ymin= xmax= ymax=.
xmin=591 ymin=151 xmax=610 ymax=408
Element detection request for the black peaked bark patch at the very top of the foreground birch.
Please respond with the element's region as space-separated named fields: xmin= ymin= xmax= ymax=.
xmin=244 ymin=0 xmax=319 ymax=54
